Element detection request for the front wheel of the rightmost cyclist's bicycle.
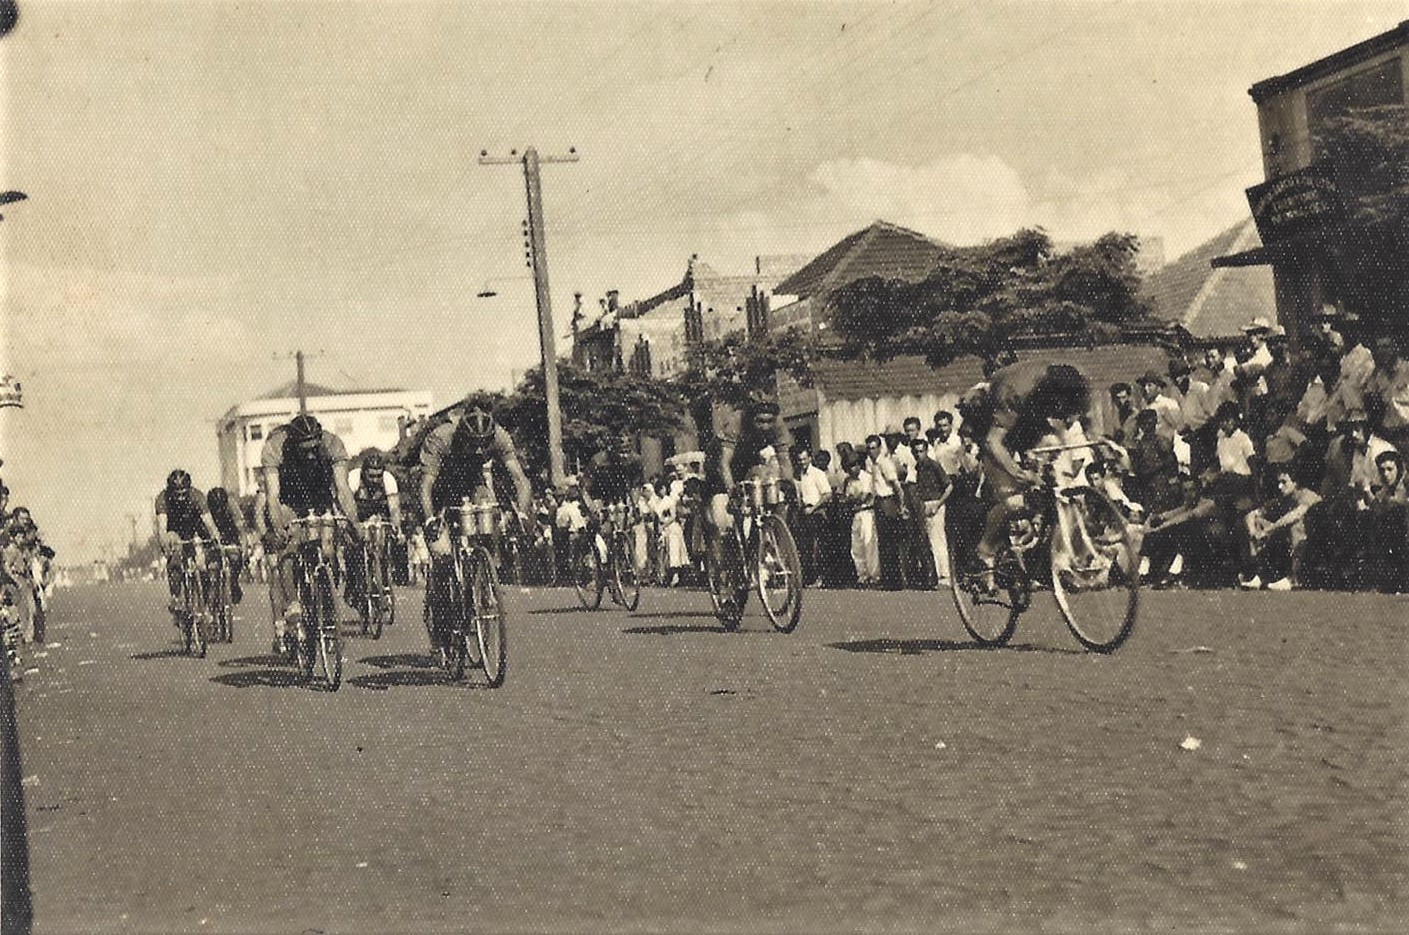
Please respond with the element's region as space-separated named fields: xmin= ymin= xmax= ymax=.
xmin=1051 ymin=490 xmax=1140 ymax=652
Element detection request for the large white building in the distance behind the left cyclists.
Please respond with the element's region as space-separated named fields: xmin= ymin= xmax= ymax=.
xmin=216 ymin=383 xmax=431 ymax=497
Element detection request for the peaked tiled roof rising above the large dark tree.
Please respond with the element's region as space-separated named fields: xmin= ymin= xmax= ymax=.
xmin=774 ymin=221 xmax=950 ymax=299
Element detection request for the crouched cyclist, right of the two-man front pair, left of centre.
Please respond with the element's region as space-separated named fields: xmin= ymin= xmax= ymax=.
xmin=420 ymin=406 xmax=533 ymax=652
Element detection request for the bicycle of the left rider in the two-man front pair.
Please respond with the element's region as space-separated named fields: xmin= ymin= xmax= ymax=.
xmin=281 ymin=513 xmax=348 ymax=691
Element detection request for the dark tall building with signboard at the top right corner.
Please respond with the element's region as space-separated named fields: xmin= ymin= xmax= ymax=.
xmin=1213 ymin=21 xmax=1409 ymax=337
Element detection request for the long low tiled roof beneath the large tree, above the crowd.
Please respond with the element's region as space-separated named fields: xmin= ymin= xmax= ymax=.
xmin=813 ymin=344 xmax=1169 ymax=401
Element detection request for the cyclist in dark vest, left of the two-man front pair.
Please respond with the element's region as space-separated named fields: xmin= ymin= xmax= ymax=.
xmin=259 ymin=415 xmax=361 ymax=653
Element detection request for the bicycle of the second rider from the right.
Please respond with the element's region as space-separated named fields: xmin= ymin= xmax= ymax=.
xmin=705 ymin=477 xmax=802 ymax=634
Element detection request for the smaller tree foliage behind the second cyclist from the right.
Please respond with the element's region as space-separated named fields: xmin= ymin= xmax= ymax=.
xmin=675 ymin=327 xmax=813 ymax=404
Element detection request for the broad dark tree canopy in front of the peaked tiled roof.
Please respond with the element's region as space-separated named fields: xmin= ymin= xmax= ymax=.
xmin=827 ymin=228 xmax=1148 ymax=366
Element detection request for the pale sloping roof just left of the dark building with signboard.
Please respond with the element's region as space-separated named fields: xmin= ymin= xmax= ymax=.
xmin=1143 ymin=218 xmax=1277 ymax=338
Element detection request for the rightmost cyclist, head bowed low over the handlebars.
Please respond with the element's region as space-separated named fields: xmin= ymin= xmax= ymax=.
xmin=971 ymin=360 xmax=1091 ymax=584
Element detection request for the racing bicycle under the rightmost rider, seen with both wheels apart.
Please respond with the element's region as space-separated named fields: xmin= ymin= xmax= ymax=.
xmin=950 ymin=441 xmax=1140 ymax=653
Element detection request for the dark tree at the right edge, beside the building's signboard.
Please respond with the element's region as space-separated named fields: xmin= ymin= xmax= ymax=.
xmin=1316 ymin=106 xmax=1409 ymax=338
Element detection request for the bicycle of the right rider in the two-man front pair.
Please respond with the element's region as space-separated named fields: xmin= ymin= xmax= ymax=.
xmin=426 ymin=497 xmax=509 ymax=689
